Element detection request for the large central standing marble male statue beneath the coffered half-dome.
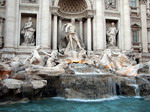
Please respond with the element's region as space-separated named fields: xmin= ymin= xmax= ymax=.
xmin=61 ymin=18 xmax=83 ymax=52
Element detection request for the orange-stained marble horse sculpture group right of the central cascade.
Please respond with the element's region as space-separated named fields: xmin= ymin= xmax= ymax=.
xmin=97 ymin=49 xmax=145 ymax=76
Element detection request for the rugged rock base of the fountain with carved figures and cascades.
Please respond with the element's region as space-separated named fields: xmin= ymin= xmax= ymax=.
xmin=0 ymin=46 xmax=150 ymax=99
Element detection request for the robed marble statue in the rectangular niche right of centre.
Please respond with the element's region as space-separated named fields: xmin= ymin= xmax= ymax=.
xmin=106 ymin=22 xmax=118 ymax=46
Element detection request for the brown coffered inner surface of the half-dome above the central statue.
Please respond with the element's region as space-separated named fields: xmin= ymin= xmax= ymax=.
xmin=58 ymin=0 xmax=87 ymax=13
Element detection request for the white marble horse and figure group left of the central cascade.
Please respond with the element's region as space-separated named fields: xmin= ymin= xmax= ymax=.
xmin=24 ymin=46 xmax=68 ymax=75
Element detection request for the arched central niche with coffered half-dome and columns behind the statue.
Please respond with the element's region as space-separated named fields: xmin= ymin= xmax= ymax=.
xmin=52 ymin=0 xmax=94 ymax=50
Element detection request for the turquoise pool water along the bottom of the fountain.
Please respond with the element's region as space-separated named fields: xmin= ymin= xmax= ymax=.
xmin=0 ymin=98 xmax=150 ymax=112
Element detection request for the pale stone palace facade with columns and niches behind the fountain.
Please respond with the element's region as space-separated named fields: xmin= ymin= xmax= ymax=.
xmin=0 ymin=0 xmax=150 ymax=59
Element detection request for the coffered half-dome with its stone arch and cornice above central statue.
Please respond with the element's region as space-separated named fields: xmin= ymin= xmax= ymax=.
xmin=52 ymin=0 xmax=94 ymax=19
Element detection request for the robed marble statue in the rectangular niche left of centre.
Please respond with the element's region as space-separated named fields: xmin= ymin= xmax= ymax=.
xmin=21 ymin=17 xmax=35 ymax=45
